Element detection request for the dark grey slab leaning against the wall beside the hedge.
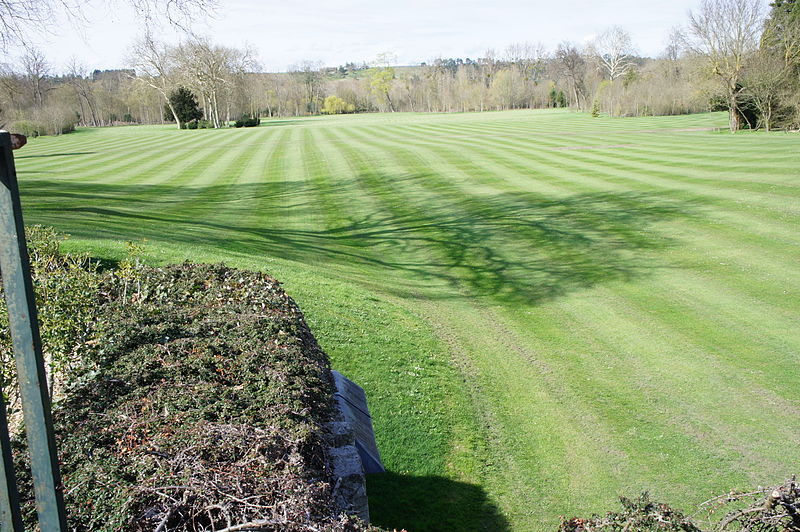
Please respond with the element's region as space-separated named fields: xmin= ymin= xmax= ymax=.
xmin=332 ymin=371 xmax=386 ymax=473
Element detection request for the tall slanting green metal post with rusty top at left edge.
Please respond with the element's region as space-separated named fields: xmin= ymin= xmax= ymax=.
xmin=0 ymin=131 xmax=67 ymax=532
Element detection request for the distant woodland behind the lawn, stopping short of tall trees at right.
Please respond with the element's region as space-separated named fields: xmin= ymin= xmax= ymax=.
xmin=0 ymin=38 xmax=708 ymax=133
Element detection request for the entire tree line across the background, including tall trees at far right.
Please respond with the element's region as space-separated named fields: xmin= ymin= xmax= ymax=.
xmin=0 ymin=0 xmax=800 ymax=132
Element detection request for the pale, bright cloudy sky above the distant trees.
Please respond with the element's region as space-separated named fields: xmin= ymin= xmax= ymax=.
xmin=18 ymin=0 xmax=768 ymax=72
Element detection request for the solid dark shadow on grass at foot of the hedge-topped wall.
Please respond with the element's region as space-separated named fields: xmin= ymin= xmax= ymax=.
xmin=367 ymin=472 xmax=510 ymax=532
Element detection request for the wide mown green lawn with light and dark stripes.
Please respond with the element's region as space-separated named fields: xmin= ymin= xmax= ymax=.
xmin=12 ymin=111 xmax=800 ymax=531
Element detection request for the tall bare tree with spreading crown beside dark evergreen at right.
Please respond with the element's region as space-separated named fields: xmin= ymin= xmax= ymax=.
xmin=689 ymin=0 xmax=764 ymax=132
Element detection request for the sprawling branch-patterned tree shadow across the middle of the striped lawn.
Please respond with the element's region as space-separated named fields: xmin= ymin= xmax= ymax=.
xmin=15 ymin=174 xmax=696 ymax=304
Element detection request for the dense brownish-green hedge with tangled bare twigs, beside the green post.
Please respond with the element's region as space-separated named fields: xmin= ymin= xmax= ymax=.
xmin=2 ymin=231 xmax=378 ymax=532
